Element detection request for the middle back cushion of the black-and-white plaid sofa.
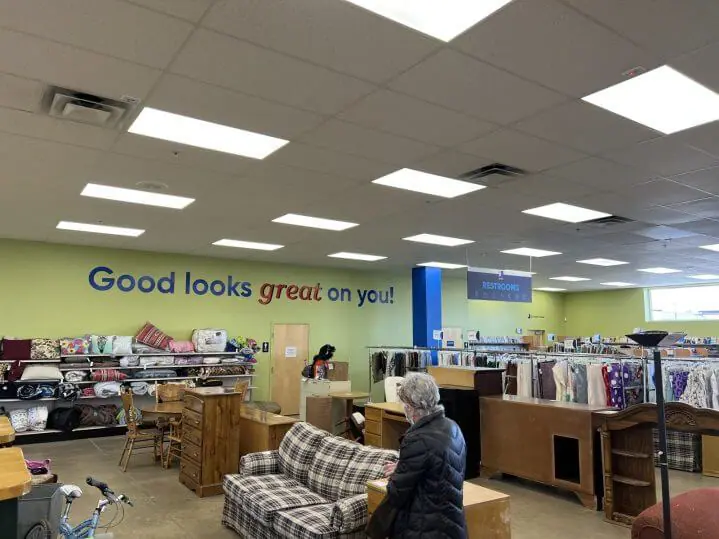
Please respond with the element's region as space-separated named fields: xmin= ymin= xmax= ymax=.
xmin=307 ymin=436 xmax=358 ymax=501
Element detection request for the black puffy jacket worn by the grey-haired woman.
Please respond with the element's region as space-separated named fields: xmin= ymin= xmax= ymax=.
xmin=387 ymin=410 xmax=467 ymax=539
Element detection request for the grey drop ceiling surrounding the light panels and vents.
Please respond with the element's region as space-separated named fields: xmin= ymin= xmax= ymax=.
xmin=0 ymin=0 xmax=719 ymax=290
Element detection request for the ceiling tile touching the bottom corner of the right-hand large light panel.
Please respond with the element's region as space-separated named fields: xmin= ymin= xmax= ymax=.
xmin=604 ymin=135 xmax=719 ymax=176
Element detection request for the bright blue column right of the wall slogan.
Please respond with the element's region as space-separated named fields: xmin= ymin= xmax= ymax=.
xmin=412 ymin=267 xmax=442 ymax=355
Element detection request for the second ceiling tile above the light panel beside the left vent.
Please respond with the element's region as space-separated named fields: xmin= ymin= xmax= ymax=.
xmin=171 ymin=30 xmax=374 ymax=114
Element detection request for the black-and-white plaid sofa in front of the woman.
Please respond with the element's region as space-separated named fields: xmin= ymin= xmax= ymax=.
xmin=222 ymin=423 xmax=397 ymax=539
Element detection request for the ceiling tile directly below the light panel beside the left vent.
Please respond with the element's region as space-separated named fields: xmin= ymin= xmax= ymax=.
xmin=112 ymin=133 xmax=255 ymax=174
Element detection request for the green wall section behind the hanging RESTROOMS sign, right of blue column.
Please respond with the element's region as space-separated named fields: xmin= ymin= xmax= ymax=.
xmin=442 ymin=278 xmax=564 ymax=336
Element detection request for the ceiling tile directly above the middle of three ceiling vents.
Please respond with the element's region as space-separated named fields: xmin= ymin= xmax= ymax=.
xmin=458 ymin=129 xmax=585 ymax=171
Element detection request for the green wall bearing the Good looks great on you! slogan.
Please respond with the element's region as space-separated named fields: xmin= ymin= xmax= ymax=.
xmin=0 ymin=240 xmax=412 ymax=399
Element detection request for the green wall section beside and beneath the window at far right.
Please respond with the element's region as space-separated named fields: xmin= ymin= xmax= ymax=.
xmin=565 ymin=289 xmax=719 ymax=337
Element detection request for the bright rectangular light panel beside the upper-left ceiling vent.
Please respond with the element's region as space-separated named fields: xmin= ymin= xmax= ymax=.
xmin=128 ymin=107 xmax=289 ymax=159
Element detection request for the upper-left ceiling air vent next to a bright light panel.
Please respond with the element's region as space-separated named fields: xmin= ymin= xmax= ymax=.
xmin=43 ymin=86 xmax=135 ymax=129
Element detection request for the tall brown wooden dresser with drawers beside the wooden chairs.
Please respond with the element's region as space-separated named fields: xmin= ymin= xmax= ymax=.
xmin=180 ymin=387 xmax=244 ymax=497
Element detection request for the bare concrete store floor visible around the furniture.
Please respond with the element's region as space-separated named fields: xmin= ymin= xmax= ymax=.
xmin=23 ymin=437 xmax=719 ymax=539
